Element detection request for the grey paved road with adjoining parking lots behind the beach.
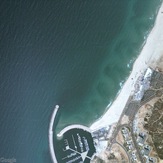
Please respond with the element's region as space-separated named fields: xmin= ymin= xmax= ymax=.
xmin=108 ymin=71 xmax=163 ymax=163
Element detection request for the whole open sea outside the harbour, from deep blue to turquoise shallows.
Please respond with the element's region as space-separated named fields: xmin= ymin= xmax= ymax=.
xmin=0 ymin=0 xmax=161 ymax=163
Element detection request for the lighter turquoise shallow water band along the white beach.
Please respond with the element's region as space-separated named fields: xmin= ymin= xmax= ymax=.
xmin=56 ymin=1 xmax=160 ymax=131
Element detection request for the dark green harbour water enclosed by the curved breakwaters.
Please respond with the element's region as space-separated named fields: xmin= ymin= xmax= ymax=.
xmin=54 ymin=129 xmax=96 ymax=163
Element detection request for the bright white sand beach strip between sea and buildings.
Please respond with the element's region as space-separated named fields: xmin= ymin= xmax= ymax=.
xmin=90 ymin=3 xmax=163 ymax=130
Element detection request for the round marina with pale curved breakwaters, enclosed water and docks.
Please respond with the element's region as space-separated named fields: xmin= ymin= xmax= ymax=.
xmin=49 ymin=105 xmax=96 ymax=163
